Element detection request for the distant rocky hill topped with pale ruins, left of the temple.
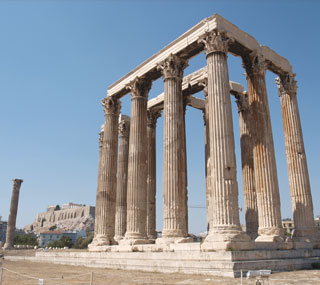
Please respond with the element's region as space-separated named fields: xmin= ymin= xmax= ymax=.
xmin=25 ymin=203 xmax=95 ymax=233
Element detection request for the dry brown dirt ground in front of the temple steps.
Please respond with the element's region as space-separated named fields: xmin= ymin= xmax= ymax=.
xmin=0 ymin=251 xmax=320 ymax=285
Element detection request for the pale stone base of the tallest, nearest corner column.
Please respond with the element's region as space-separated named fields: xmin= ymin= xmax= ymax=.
xmin=201 ymin=227 xmax=254 ymax=251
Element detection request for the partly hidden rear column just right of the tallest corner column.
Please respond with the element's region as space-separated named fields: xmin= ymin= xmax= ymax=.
xmin=236 ymin=93 xmax=259 ymax=239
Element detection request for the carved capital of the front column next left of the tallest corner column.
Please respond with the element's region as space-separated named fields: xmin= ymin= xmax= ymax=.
xmin=157 ymin=54 xmax=188 ymax=80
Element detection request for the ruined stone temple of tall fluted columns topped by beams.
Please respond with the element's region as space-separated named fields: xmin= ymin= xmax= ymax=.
xmin=89 ymin=14 xmax=320 ymax=257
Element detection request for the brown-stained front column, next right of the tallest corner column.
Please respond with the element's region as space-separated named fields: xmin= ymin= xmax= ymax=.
xmin=244 ymin=52 xmax=284 ymax=242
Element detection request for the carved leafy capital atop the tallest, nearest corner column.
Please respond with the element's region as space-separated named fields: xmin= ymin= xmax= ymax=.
xmin=198 ymin=30 xmax=233 ymax=56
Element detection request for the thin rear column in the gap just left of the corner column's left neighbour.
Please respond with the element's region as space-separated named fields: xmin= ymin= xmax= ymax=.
xmin=147 ymin=110 xmax=161 ymax=239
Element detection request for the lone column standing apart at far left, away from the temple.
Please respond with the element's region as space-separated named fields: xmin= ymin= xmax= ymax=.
xmin=4 ymin=179 xmax=23 ymax=249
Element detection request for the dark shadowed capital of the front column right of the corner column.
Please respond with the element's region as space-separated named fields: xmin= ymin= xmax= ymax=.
xmin=242 ymin=51 xmax=268 ymax=76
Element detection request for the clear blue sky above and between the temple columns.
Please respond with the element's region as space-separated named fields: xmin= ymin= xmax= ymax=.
xmin=0 ymin=0 xmax=320 ymax=233
